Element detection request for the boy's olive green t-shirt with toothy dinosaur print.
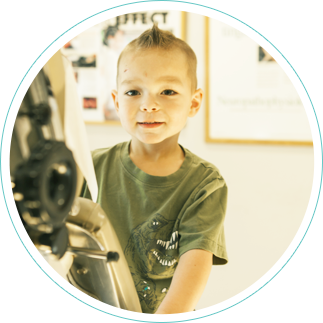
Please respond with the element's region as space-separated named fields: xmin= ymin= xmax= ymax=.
xmin=83 ymin=142 xmax=228 ymax=315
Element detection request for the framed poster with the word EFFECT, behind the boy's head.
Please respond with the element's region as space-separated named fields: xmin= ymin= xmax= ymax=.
xmin=54 ymin=8 xmax=186 ymax=125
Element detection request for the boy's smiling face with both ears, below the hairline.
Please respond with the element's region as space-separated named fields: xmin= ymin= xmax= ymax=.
xmin=112 ymin=49 xmax=203 ymax=144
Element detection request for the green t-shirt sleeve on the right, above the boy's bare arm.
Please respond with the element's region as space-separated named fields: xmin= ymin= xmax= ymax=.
xmin=179 ymin=178 xmax=228 ymax=265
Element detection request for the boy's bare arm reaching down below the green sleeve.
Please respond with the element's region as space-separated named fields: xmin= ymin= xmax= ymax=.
xmin=153 ymin=249 xmax=213 ymax=316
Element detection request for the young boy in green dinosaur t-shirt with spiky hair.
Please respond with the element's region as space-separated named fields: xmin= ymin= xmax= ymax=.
xmin=84 ymin=25 xmax=227 ymax=316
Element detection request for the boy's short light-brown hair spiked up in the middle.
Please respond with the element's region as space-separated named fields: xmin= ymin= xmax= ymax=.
xmin=118 ymin=23 xmax=197 ymax=91
